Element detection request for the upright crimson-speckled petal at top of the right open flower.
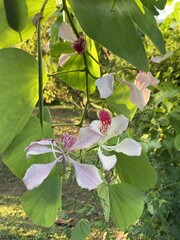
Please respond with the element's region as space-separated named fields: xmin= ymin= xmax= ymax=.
xmin=98 ymin=110 xmax=111 ymax=134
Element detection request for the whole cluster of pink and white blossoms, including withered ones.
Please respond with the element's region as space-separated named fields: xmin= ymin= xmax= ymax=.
xmin=23 ymin=23 xmax=171 ymax=190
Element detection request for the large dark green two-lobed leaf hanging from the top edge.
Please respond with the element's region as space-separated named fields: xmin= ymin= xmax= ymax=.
xmin=69 ymin=0 xmax=165 ymax=71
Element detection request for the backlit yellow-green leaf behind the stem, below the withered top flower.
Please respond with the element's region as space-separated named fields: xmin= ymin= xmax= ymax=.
xmin=59 ymin=38 xmax=100 ymax=94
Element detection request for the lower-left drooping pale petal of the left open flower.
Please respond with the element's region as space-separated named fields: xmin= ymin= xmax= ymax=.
xmin=23 ymin=160 xmax=57 ymax=190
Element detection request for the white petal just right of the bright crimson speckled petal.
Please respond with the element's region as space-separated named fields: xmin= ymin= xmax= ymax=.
xmin=107 ymin=115 xmax=129 ymax=138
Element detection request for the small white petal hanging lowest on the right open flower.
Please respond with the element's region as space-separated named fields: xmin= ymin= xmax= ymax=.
xmin=98 ymin=148 xmax=117 ymax=171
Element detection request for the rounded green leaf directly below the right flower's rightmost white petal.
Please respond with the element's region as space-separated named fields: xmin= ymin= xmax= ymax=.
xmin=115 ymin=153 xmax=157 ymax=190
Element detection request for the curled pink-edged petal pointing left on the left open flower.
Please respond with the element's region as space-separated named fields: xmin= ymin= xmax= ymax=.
xmin=25 ymin=139 xmax=59 ymax=158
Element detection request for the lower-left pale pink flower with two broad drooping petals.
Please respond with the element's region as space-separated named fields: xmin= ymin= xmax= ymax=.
xmin=23 ymin=135 xmax=103 ymax=190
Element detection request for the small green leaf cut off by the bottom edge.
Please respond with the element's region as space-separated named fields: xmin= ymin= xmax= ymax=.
xmin=71 ymin=219 xmax=90 ymax=240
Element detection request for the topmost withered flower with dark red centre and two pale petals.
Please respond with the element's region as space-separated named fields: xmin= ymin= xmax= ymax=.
xmin=58 ymin=22 xmax=86 ymax=67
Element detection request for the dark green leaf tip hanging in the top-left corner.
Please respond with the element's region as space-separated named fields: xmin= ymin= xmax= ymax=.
xmin=4 ymin=0 xmax=28 ymax=33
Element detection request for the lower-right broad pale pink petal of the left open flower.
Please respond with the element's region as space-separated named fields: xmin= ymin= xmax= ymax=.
xmin=70 ymin=159 xmax=103 ymax=190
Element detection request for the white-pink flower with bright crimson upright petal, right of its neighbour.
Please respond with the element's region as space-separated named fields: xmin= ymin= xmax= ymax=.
xmin=71 ymin=110 xmax=142 ymax=170
